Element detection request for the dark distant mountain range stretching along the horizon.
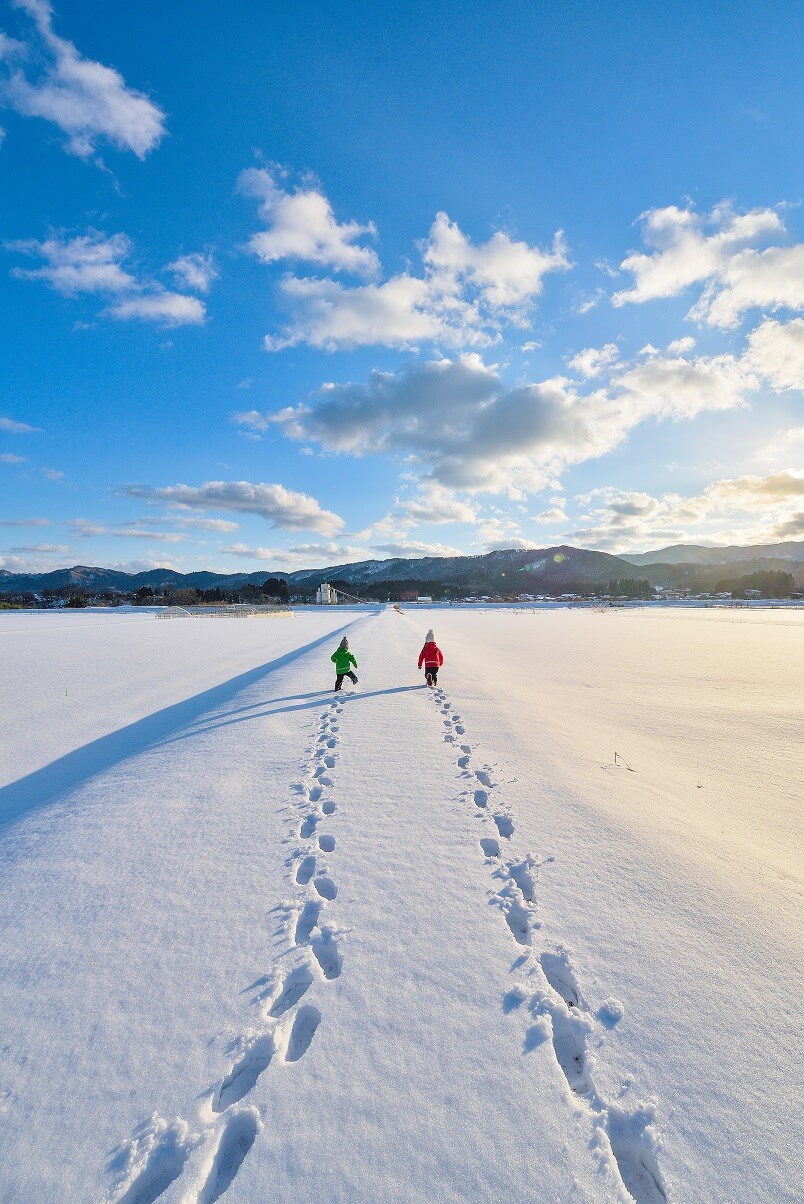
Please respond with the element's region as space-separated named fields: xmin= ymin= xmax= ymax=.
xmin=0 ymin=541 xmax=804 ymax=594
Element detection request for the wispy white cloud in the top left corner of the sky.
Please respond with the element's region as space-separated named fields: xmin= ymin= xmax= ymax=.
xmin=0 ymin=0 xmax=165 ymax=159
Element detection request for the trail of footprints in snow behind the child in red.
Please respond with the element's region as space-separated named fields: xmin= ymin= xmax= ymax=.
xmin=432 ymin=686 xmax=670 ymax=1204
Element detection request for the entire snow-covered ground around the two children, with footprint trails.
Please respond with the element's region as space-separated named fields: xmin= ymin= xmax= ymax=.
xmin=0 ymin=609 xmax=804 ymax=1204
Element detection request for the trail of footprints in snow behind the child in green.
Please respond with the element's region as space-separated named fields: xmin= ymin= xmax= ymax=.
xmin=108 ymin=698 xmax=343 ymax=1204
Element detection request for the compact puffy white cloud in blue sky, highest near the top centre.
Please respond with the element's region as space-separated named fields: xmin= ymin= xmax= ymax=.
xmin=238 ymin=167 xmax=380 ymax=278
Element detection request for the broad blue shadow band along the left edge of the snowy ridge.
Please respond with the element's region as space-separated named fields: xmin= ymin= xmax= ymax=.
xmin=0 ymin=624 xmax=351 ymax=831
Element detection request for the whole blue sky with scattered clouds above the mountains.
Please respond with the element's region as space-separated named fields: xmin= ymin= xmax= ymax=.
xmin=0 ymin=0 xmax=804 ymax=572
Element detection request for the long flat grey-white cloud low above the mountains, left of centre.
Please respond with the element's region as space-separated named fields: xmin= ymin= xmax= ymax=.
xmin=120 ymin=480 xmax=344 ymax=535
